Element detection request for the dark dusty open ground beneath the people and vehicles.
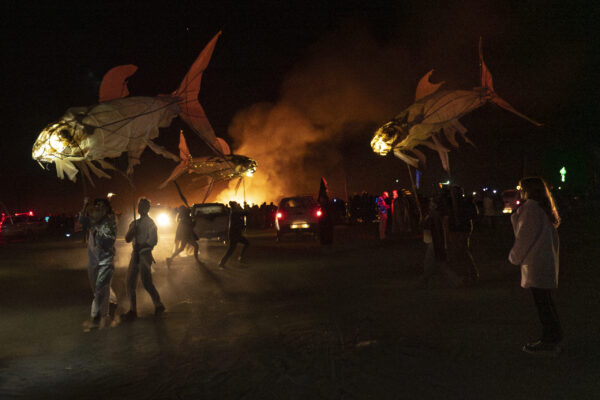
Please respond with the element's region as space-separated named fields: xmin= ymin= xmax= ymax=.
xmin=0 ymin=217 xmax=600 ymax=399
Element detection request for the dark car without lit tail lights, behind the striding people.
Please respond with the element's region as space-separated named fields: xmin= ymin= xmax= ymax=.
xmin=192 ymin=203 xmax=231 ymax=241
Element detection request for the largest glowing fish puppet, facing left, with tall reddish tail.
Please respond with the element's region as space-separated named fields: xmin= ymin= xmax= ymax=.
xmin=32 ymin=32 xmax=221 ymax=181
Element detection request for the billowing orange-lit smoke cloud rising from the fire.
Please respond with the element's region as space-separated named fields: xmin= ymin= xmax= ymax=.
xmin=217 ymin=24 xmax=415 ymax=203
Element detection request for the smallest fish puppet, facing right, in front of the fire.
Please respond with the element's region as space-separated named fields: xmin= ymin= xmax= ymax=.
xmin=159 ymin=133 xmax=256 ymax=188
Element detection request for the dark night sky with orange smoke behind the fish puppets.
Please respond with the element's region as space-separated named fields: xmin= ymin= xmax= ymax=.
xmin=0 ymin=1 xmax=600 ymax=216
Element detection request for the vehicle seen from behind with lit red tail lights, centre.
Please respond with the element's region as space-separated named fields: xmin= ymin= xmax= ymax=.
xmin=275 ymin=196 xmax=322 ymax=241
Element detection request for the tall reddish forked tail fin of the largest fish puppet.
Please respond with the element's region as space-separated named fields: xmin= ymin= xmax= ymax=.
xmin=174 ymin=31 xmax=221 ymax=143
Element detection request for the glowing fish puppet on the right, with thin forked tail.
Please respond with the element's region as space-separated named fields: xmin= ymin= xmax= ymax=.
xmin=371 ymin=39 xmax=541 ymax=171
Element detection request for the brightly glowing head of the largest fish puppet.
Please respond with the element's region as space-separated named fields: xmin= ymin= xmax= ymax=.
xmin=31 ymin=121 xmax=83 ymax=163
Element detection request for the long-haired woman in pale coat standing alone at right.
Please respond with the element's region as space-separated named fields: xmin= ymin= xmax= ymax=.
xmin=508 ymin=177 xmax=563 ymax=354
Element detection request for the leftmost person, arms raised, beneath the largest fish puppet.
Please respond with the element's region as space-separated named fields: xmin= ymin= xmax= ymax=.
xmin=79 ymin=197 xmax=117 ymax=330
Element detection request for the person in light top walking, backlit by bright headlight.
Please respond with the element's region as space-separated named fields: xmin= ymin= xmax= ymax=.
xmin=122 ymin=197 xmax=165 ymax=321
